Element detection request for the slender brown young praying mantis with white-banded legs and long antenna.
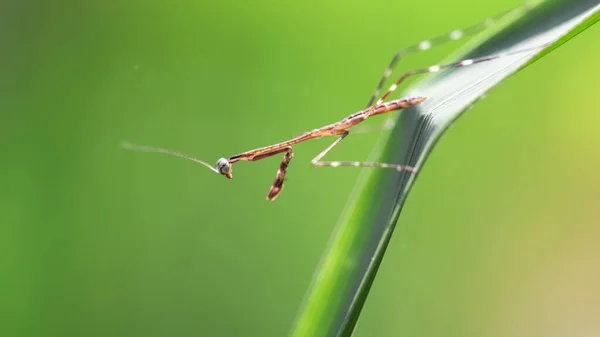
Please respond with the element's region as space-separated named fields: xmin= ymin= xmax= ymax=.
xmin=122 ymin=5 xmax=547 ymax=200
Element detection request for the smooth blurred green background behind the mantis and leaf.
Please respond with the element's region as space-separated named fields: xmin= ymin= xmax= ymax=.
xmin=0 ymin=0 xmax=600 ymax=336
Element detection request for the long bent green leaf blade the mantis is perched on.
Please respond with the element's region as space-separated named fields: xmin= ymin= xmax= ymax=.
xmin=292 ymin=0 xmax=600 ymax=336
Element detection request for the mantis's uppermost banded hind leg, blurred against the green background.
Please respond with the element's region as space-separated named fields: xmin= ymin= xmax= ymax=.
xmin=366 ymin=2 xmax=532 ymax=108
